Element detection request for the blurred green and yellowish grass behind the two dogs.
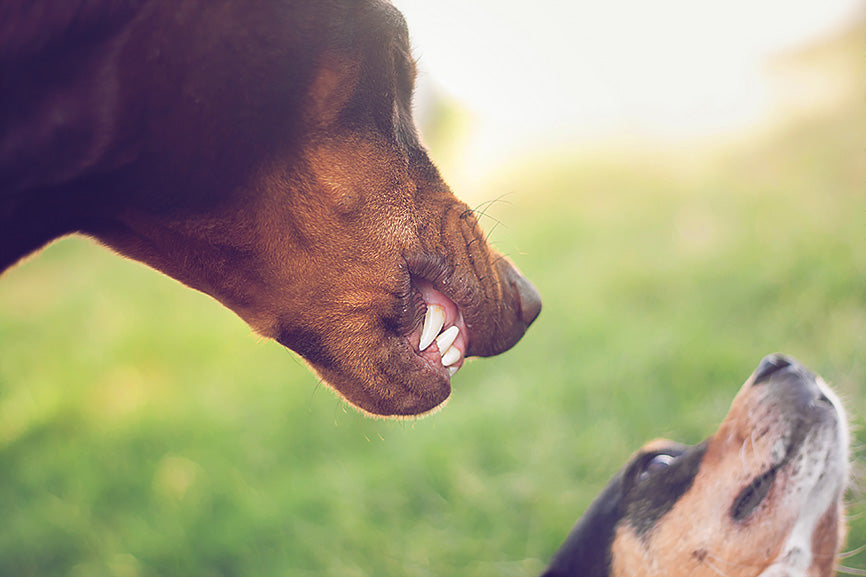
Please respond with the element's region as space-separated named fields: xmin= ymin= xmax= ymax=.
xmin=0 ymin=15 xmax=866 ymax=577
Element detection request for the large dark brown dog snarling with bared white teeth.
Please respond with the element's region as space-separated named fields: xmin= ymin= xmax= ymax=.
xmin=0 ymin=0 xmax=541 ymax=415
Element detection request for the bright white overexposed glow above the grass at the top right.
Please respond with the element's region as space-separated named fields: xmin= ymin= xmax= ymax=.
xmin=393 ymin=0 xmax=866 ymax=180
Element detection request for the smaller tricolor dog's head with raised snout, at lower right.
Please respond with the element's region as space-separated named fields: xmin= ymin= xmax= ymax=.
xmin=545 ymin=355 xmax=848 ymax=577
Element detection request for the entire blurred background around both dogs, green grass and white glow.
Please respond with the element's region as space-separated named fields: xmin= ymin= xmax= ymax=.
xmin=0 ymin=0 xmax=866 ymax=577
